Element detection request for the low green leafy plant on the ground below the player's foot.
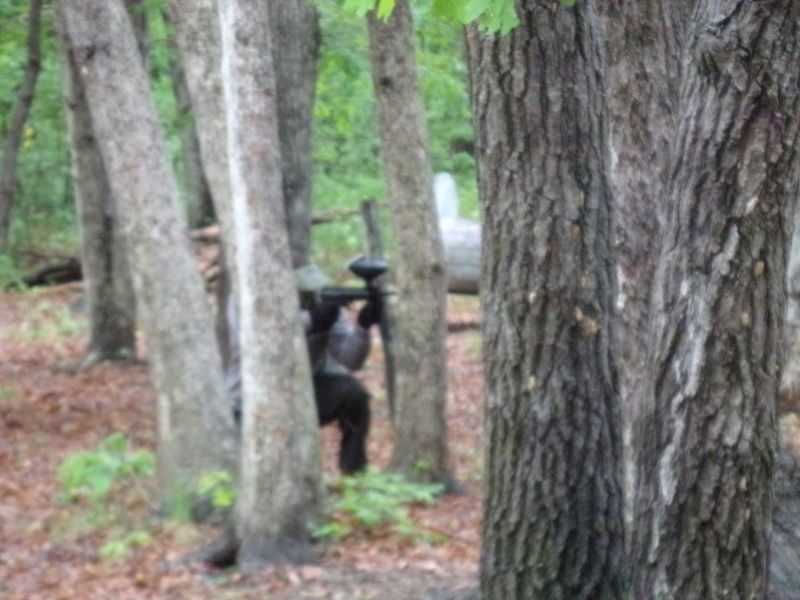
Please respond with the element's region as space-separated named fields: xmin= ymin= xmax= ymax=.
xmin=312 ymin=469 xmax=444 ymax=541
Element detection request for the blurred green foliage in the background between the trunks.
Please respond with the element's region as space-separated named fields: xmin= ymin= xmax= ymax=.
xmin=0 ymin=0 xmax=478 ymax=284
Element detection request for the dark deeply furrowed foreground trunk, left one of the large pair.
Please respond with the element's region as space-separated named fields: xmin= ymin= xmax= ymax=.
xmin=468 ymin=0 xmax=623 ymax=600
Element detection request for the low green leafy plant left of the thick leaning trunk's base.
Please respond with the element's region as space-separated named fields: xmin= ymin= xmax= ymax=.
xmin=58 ymin=432 xmax=154 ymax=503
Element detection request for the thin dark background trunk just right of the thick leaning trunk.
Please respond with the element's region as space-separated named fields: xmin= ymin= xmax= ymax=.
xmin=165 ymin=14 xmax=215 ymax=228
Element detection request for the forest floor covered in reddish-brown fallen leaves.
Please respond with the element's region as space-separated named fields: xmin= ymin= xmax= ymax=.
xmin=0 ymin=284 xmax=483 ymax=600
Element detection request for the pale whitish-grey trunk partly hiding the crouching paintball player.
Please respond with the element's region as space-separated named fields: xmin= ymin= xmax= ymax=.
xmin=220 ymin=0 xmax=322 ymax=571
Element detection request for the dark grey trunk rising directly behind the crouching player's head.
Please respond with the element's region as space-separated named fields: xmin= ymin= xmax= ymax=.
xmin=268 ymin=0 xmax=320 ymax=267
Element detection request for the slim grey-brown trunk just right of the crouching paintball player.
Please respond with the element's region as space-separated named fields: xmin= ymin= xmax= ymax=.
xmin=367 ymin=0 xmax=450 ymax=483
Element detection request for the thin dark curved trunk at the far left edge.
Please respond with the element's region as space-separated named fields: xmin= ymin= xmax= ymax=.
xmin=0 ymin=0 xmax=42 ymax=252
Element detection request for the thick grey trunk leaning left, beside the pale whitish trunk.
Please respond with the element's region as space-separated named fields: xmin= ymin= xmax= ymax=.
xmin=57 ymin=0 xmax=236 ymax=508
